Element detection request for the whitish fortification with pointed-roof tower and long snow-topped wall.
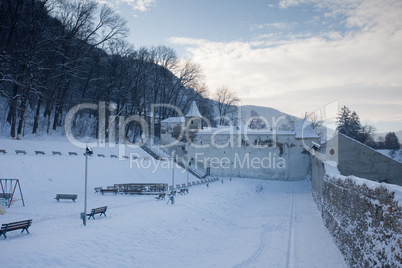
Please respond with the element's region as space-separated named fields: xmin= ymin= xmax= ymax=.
xmin=161 ymin=102 xmax=319 ymax=180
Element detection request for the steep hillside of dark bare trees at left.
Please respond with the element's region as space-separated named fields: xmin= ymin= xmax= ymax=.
xmin=0 ymin=0 xmax=212 ymax=139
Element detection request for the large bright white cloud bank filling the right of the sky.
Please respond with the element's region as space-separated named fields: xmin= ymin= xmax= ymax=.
xmin=170 ymin=0 xmax=402 ymax=130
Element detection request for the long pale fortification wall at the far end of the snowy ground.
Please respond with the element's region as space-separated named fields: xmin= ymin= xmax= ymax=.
xmin=186 ymin=132 xmax=315 ymax=181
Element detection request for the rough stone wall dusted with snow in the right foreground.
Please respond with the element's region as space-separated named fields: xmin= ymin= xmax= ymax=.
xmin=312 ymin=161 xmax=402 ymax=267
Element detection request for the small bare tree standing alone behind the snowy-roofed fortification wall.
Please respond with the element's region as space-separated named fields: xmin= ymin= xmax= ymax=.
xmin=214 ymin=86 xmax=240 ymax=125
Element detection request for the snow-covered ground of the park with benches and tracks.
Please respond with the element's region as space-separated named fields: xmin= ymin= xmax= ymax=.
xmin=0 ymin=139 xmax=346 ymax=267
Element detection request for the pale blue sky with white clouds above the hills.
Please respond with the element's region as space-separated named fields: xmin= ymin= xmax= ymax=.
xmin=108 ymin=0 xmax=402 ymax=132
